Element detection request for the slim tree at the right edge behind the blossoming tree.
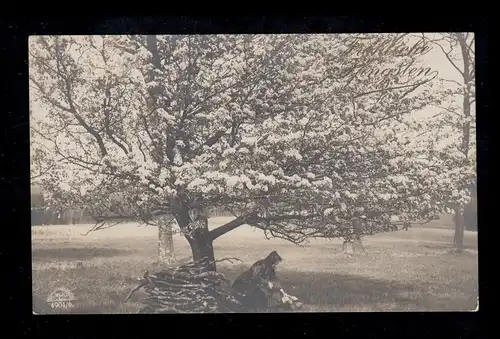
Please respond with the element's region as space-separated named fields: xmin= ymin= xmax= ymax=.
xmin=424 ymin=33 xmax=477 ymax=251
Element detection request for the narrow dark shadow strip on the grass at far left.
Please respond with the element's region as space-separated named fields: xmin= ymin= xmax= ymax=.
xmin=31 ymin=247 xmax=133 ymax=260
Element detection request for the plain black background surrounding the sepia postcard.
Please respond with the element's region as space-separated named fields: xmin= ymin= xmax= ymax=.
xmin=0 ymin=16 xmax=492 ymax=339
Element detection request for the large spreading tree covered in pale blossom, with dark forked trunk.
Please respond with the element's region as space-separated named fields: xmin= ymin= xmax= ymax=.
xmin=30 ymin=34 xmax=458 ymax=270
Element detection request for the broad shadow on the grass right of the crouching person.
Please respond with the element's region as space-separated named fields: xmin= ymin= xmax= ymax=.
xmin=221 ymin=268 xmax=477 ymax=312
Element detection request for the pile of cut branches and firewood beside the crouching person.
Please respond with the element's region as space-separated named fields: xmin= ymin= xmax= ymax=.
xmin=126 ymin=259 xmax=246 ymax=313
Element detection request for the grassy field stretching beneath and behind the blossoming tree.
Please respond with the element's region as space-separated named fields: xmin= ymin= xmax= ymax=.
xmin=32 ymin=217 xmax=478 ymax=313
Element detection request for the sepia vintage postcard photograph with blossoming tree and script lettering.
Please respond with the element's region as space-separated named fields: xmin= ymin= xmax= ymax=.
xmin=28 ymin=32 xmax=479 ymax=315
